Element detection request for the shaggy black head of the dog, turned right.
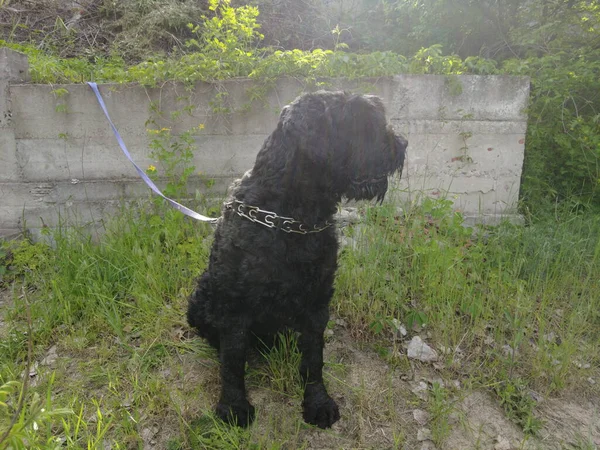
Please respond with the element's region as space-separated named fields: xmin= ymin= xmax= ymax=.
xmin=278 ymin=91 xmax=408 ymax=200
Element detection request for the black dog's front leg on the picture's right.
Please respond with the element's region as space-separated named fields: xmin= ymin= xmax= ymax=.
xmin=298 ymin=313 xmax=340 ymax=428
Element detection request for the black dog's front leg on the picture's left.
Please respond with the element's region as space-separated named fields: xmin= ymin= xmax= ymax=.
xmin=216 ymin=326 xmax=254 ymax=427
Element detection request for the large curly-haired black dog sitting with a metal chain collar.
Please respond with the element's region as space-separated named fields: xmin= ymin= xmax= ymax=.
xmin=188 ymin=91 xmax=407 ymax=428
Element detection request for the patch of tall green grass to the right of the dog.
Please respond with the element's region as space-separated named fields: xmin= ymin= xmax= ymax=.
xmin=334 ymin=200 xmax=600 ymax=433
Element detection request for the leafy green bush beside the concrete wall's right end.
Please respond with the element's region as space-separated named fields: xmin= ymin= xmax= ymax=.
xmin=504 ymin=50 xmax=600 ymax=210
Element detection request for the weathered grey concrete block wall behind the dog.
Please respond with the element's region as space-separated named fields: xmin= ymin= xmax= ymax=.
xmin=0 ymin=49 xmax=529 ymax=239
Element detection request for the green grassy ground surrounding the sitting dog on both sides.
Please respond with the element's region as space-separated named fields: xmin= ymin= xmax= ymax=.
xmin=0 ymin=200 xmax=600 ymax=449
